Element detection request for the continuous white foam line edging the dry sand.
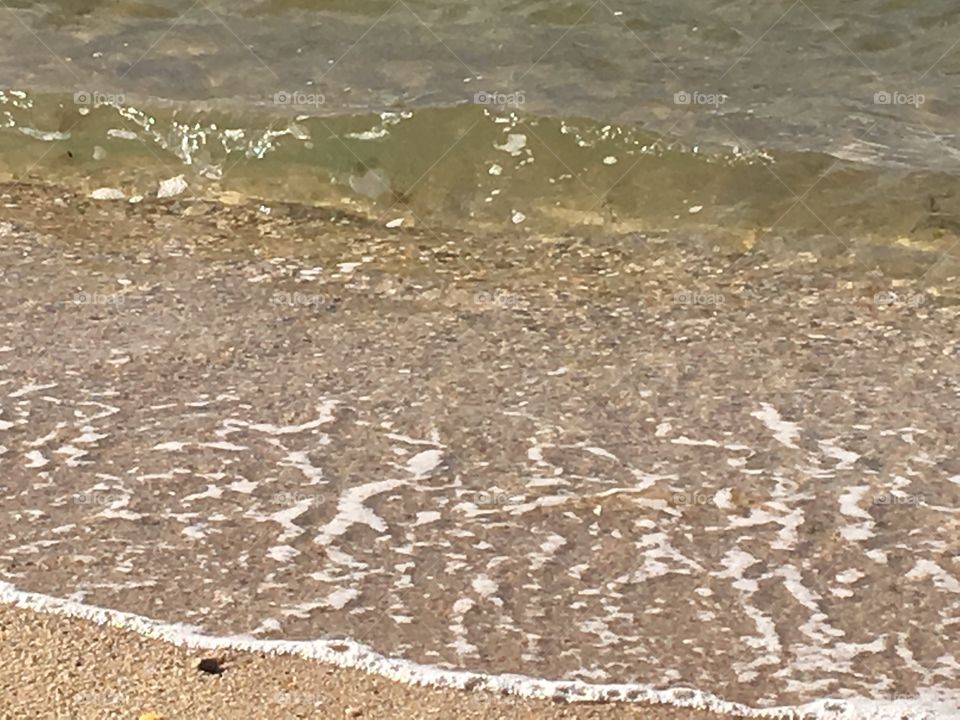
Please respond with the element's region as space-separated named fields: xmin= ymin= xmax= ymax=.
xmin=0 ymin=581 xmax=960 ymax=720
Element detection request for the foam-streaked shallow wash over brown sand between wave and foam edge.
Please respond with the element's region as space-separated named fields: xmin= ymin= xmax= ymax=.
xmin=0 ymin=185 xmax=960 ymax=707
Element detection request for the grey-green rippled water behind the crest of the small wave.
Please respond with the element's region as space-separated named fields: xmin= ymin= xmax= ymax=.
xmin=0 ymin=0 xmax=960 ymax=171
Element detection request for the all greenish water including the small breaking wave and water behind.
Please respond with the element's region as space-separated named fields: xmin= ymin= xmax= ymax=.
xmin=0 ymin=0 xmax=960 ymax=249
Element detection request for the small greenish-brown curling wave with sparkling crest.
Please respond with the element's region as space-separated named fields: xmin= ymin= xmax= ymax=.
xmin=0 ymin=92 xmax=960 ymax=252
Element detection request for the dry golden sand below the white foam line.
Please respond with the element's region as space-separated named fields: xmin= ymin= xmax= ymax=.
xmin=0 ymin=605 xmax=720 ymax=720
